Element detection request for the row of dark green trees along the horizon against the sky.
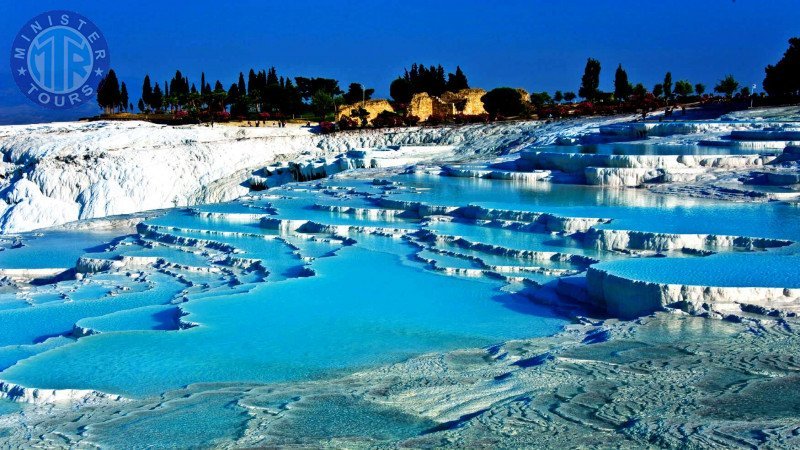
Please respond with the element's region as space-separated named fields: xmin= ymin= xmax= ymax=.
xmin=97 ymin=38 xmax=800 ymax=122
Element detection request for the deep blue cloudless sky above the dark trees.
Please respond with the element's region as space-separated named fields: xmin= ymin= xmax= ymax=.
xmin=0 ymin=0 xmax=800 ymax=123
